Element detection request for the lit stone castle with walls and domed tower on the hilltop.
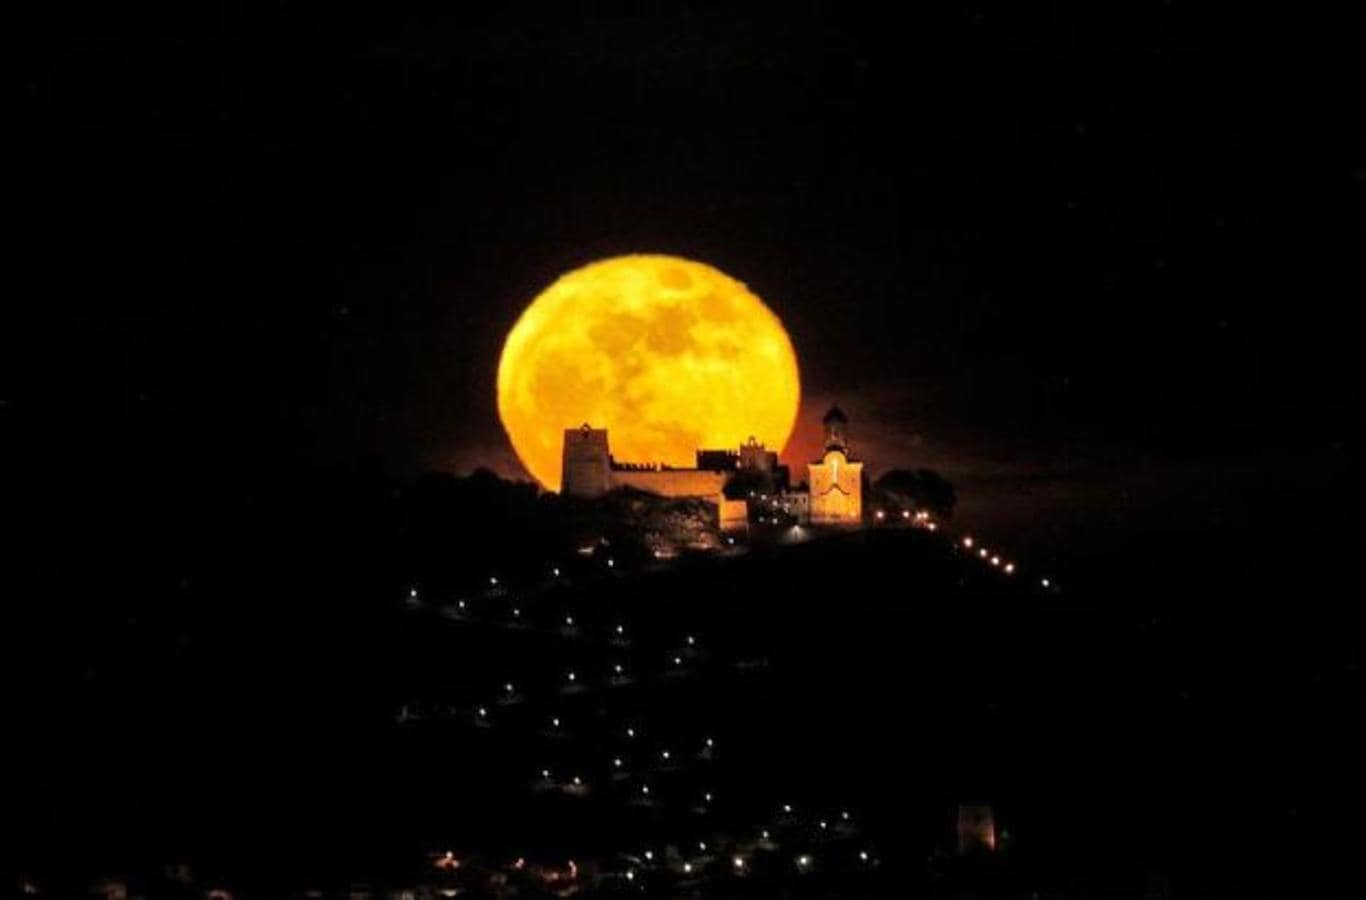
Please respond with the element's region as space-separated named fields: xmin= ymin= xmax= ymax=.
xmin=560 ymin=407 xmax=863 ymax=527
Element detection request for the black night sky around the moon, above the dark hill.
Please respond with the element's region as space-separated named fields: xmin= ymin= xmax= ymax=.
xmin=16 ymin=1 xmax=1366 ymax=559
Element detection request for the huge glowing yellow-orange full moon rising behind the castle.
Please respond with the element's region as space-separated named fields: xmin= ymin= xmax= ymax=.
xmin=497 ymin=255 xmax=802 ymax=490
